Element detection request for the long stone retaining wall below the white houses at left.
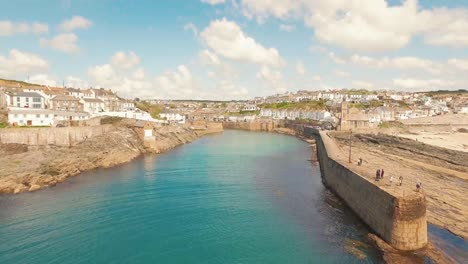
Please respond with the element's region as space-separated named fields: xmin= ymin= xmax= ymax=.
xmin=0 ymin=125 xmax=112 ymax=147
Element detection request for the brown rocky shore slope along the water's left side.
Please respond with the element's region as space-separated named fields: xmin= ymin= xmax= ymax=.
xmin=0 ymin=123 xmax=222 ymax=194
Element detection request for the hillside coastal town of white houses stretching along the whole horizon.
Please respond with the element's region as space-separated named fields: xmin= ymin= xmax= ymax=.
xmin=0 ymin=81 xmax=468 ymax=130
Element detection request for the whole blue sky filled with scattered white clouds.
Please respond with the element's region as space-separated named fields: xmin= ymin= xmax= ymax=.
xmin=0 ymin=0 xmax=468 ymax=100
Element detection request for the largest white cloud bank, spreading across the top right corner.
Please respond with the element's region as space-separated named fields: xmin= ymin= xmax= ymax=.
xmin=240 ymin=0 xmax=468 ymax=52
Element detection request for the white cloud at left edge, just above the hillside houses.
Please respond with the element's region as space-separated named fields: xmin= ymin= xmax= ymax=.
xmin=0 ymin=49 xmax=49 ymax=78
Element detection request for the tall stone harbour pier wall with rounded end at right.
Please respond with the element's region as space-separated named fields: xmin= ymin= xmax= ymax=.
xmin=303 ymin=127 xmax=427 ymax=250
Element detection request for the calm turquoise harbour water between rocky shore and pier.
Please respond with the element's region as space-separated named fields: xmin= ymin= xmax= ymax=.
xmin=0 ymin=131 xmax=388 ymax=263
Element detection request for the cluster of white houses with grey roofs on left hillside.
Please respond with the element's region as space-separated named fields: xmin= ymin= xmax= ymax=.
xmin=0 ymin=86 xmax=136 ymax=126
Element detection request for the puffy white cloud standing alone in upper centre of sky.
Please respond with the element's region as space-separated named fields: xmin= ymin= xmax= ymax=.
xmin=200 ymin=18 xmax=284 ymax=67
